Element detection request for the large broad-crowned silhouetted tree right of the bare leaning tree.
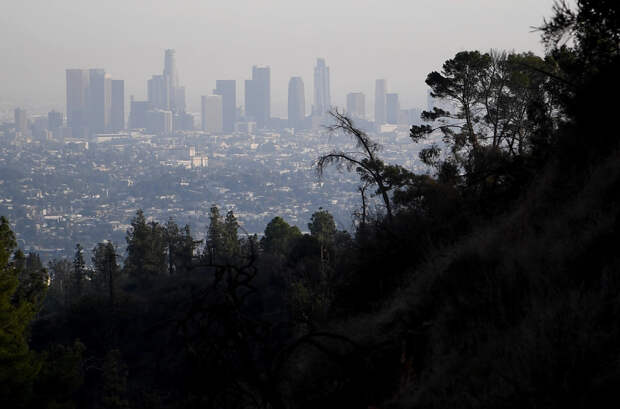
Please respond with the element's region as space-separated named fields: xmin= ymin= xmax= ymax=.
xmin=410 ymin=51 xmax=554 ymax=199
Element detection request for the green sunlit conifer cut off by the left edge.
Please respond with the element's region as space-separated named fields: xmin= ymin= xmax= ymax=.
xmin=0 ymin=217 xmax=40 ymax=408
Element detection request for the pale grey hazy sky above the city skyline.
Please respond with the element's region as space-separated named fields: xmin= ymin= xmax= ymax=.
xmin=0 ymin=0 xmax=553 ymax=116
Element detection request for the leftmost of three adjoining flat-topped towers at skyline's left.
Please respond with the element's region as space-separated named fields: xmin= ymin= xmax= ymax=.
xmin=66 ymin=69 xmax=90 ymax=132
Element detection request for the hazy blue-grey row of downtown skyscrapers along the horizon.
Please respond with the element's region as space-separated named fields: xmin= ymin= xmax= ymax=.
xmin=15 ymin=49 xmax=422 ymax=138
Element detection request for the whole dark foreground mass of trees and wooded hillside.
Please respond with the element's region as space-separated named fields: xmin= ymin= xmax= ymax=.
xmin=0 ymin=0 xmax=620 ymax=409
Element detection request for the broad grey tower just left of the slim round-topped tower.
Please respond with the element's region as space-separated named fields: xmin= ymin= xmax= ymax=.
xmin=245 ymin=65 xmax=271 ymax=128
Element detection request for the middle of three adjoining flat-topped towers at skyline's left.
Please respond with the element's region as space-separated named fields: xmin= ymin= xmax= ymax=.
xmin=88 ymin=68 xmax=112 ymax=133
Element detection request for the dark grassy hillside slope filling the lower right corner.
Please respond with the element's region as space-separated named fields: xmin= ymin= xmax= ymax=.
xmin=387 ymin=145 xmax=620 ymax=408
